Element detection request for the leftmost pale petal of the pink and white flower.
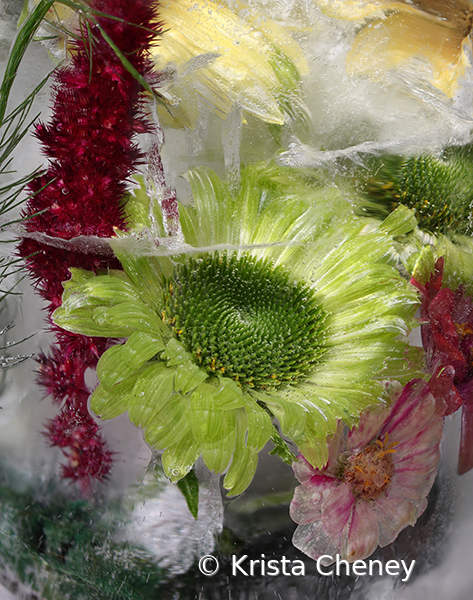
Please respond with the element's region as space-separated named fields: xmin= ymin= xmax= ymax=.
xmin=290 ymin=476 xmax=339 ymax=523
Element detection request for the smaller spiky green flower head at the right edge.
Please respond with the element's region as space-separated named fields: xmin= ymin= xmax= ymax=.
xmin=360 ymin=147 xmax=473 ymax=235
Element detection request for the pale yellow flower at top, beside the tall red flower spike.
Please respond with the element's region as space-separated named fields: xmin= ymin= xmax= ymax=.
xmin=153 ymin=0 xmax=308 ymax=128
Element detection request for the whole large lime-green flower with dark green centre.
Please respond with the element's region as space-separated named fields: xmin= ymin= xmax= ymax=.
xmin=54 ymin=165 xmax=417 ymax=494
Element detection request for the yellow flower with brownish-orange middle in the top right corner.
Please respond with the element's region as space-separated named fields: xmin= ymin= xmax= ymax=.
xmin=317 ymin=0 xmax=473 ymax=97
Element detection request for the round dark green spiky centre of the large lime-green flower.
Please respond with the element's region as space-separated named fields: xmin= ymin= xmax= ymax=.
xmin=164 ymin=253 xmax=324 ymax=389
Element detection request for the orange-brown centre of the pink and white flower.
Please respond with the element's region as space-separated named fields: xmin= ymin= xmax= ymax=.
xmin=343 ymin=434 xmax=396 ymax=500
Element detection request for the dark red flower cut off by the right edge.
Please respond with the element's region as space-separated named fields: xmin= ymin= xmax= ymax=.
xmin=412 ymin=258 xmax=473 ymax=474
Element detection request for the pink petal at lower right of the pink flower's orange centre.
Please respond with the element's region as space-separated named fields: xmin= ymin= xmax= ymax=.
xmin=373 ymin=494 xmax=417 ymax=547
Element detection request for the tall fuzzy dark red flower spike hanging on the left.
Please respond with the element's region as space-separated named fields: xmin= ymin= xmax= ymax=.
xmin=18 ymin=0 xmax=159 ymax=487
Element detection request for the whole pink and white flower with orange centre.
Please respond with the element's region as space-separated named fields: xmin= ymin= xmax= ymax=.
xmin=291 ymin=379 xmax=444 ymax=562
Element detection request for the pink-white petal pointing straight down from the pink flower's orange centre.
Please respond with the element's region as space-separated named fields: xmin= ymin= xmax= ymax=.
xmin=340 ymin=501 xmax=379 ymax=562
